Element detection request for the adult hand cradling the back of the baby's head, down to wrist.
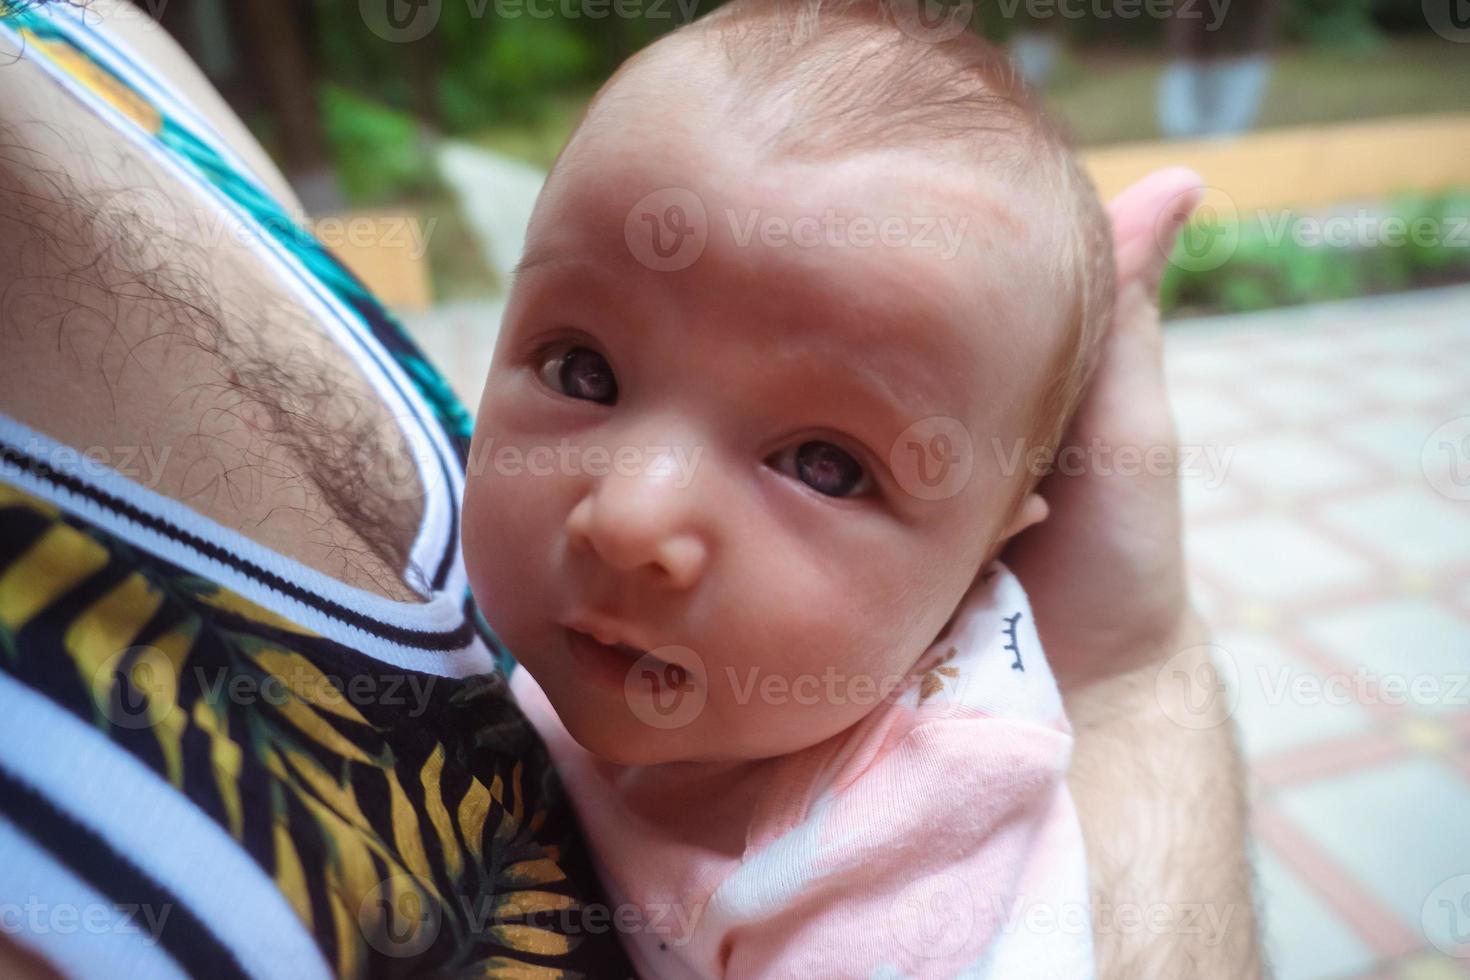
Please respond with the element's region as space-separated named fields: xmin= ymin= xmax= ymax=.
xmin=1004 ymin=167 xmax=1202 ymax=688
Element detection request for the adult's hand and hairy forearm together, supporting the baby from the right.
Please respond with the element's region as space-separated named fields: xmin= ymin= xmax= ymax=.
xmin=1005 ymin=169 xmax=1261 ymax=980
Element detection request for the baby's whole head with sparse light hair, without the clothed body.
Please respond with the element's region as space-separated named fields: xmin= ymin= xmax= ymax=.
xmin=465 ymin=0 xmax=1111 ymax=764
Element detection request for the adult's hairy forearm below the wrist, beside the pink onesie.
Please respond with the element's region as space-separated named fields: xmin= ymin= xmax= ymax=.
xmin=1066 ymin=617 xmax=1261 ymax=980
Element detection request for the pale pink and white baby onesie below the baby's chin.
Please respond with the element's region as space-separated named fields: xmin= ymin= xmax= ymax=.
xmin=512 ymin=563 xmax=1094 ymax=980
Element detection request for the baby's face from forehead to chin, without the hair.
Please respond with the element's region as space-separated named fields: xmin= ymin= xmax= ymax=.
xmin=465 ymin=109 xmax=1063 ymax=764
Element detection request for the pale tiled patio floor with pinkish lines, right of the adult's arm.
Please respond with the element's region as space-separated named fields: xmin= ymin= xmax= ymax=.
xmin=1167 ymin=288 xmax=1470 ymax=980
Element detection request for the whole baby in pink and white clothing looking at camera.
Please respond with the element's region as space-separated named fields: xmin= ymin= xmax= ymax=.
xmin=463 ymin=0 xmax=1113 ymax=980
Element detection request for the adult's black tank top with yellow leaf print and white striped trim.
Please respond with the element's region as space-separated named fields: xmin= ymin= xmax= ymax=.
xmin=0 ymin=0 xmax=629 ymax=979
